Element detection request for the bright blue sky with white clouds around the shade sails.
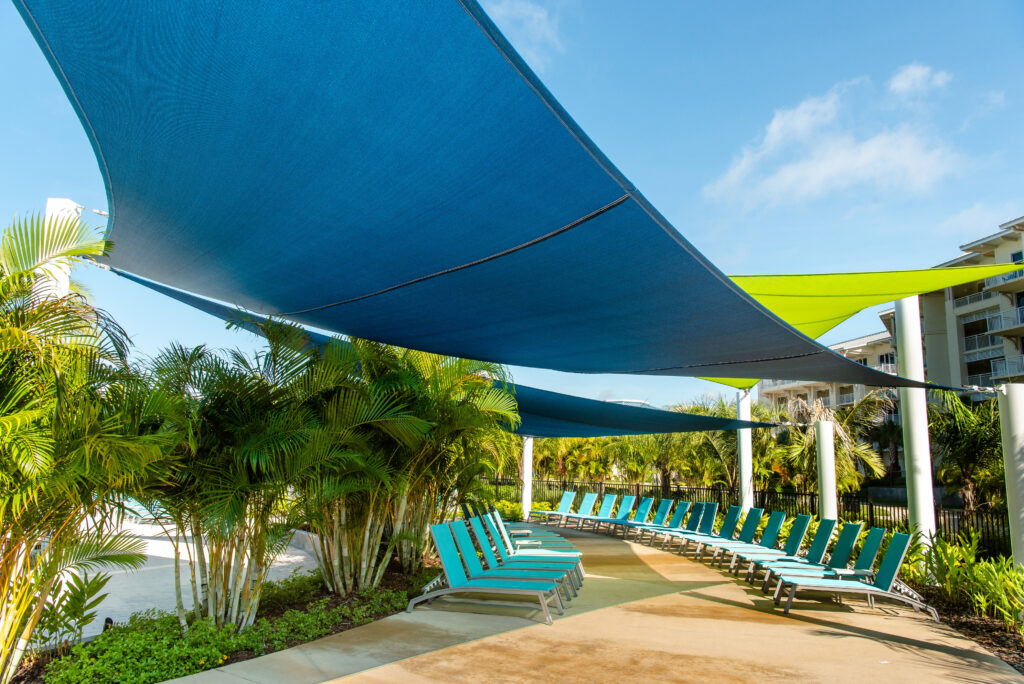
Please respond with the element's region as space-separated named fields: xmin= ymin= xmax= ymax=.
xmin=0 ymin=0 xmax=1024 ymax=405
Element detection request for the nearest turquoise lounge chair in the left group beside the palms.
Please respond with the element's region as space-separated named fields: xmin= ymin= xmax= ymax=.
xmin=406 ymin=523 xmax=565 ymax=625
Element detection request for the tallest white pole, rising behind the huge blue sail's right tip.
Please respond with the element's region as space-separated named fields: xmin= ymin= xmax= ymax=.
xmin=896 ymin=296 xmax=935 ymax=544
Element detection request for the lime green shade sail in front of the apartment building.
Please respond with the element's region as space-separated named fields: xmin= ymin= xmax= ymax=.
xmin=703 ymin=263 xmax=1021 ymax=389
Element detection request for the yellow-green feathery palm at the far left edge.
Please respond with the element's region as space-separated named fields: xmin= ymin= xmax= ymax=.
xmin=0 ymin=217 xmax=169 ymax=683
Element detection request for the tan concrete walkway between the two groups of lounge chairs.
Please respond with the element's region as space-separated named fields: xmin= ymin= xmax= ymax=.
xmin=180 ymin=531 xmax=1024 ymax=684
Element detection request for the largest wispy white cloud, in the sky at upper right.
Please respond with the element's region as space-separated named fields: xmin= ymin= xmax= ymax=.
xmin=703 ymin=80 xmax=961 ymax=208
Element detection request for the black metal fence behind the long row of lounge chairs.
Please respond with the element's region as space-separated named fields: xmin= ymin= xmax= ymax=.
xmin=490 ymin=479 xmax=1011 ymax=556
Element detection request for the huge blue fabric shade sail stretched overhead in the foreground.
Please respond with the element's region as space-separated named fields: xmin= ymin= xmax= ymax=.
xmin=15 ymin=0 xmax=920 ymax=386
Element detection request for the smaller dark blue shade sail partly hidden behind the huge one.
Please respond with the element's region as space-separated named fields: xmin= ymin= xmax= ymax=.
xmin=112 ymin=272 xmax=772 ymax=437
